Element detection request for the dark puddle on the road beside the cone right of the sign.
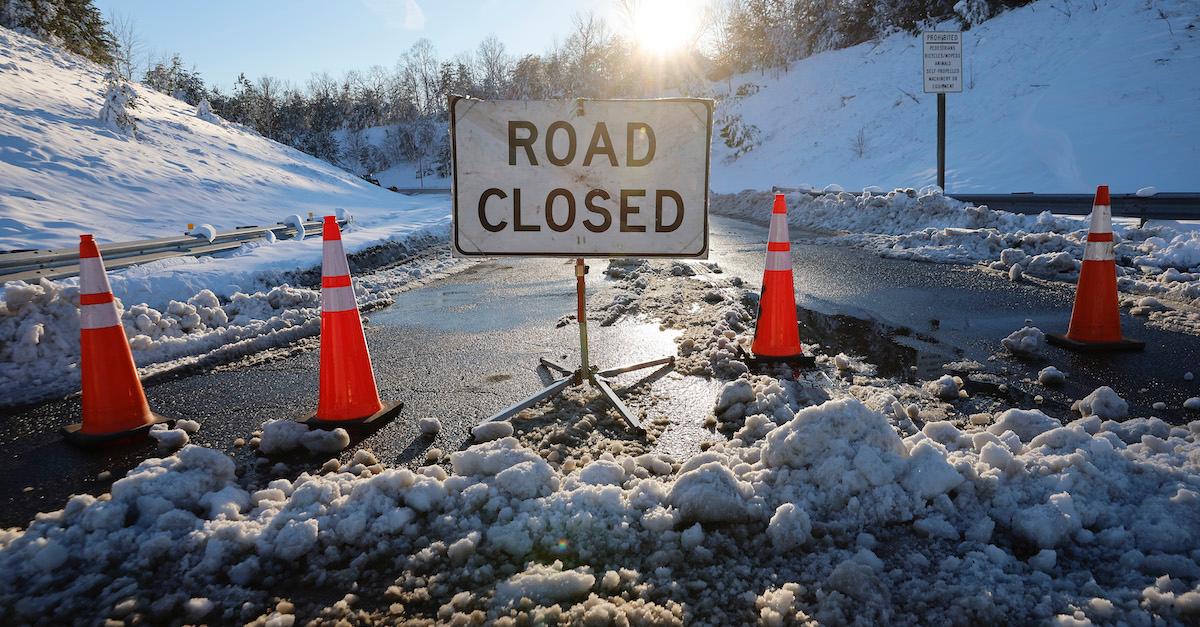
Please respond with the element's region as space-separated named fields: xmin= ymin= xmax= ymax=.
xmin=798 ymin=307 xmax=962 ymax=381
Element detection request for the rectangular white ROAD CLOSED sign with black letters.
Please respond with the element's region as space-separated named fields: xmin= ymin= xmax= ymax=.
xmin=450 ymin=97 xmax=713 ymax=258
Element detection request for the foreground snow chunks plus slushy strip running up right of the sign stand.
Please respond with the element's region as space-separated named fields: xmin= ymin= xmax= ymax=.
xmin=0 ymin=261 xmax=1200 ymax=625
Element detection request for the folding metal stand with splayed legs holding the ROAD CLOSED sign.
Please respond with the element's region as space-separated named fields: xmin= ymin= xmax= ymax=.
xmin=487 ymin=258 xmax=674 ymax=431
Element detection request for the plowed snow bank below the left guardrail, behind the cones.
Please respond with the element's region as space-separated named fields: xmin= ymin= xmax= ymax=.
xmin=0 ymin=239 xmax=455 ymax=406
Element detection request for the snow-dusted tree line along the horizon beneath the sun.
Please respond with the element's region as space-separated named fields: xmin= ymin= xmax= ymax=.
xmin=0 ymin=0 xmax=1031 ymax=177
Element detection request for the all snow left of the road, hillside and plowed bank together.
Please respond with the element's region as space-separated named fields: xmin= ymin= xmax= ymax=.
xmin=0 ymin=29 xmax=455 ymax=406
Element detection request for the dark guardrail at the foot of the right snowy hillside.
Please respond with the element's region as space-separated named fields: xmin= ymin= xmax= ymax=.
xmin=772 ymin=186 xmax=1200 ymax=223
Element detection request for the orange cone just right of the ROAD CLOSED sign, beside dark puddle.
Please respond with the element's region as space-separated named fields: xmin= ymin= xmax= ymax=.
xmin=750 ymin=193 xmax=811 ymax=362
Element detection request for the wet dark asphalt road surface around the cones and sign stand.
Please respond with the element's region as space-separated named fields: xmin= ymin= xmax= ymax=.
xmin=0 ymin=217 xmax=1200 ymax=526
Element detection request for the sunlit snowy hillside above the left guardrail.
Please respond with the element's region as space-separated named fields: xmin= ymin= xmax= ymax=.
xmin=0 ymin=29 xmax=445 ymax=250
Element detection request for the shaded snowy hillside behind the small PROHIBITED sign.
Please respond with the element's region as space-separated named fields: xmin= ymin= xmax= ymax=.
xmin=713 ymin=0 xmax=1200 ymax=193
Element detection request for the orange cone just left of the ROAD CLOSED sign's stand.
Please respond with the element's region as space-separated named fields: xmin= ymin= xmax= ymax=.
xmin=301 ymin=215 xmax=403 ymax=426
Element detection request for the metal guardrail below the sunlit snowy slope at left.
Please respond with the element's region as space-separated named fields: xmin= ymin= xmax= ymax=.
xmin=0 ymin=220 xmax=346 ymax=285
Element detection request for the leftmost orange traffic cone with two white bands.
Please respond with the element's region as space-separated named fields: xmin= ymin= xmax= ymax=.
xmin=62 ymin=235 xmax=169 ymax=444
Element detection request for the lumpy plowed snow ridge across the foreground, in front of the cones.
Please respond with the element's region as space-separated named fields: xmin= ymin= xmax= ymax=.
xmin=0 ymin=389 xmax=1200 ymax=622
